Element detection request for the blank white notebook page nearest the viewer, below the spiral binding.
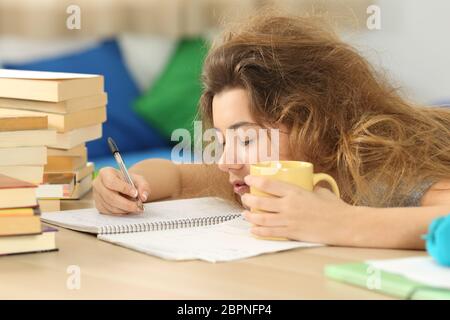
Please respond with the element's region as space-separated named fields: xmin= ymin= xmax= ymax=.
xmin=98 ymin=217 xmax=321 ymax=262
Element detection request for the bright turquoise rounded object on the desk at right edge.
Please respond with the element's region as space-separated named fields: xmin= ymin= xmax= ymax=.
xmin=426 ymin=214 xmax=450 ymax=267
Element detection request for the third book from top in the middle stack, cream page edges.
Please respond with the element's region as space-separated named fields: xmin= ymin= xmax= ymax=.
xmin=0 ymin=146 xmax=47 ymax=166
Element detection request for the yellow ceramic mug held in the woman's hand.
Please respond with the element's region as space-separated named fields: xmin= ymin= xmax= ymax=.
xmin=250 ymin=161 xmax=340 ymax=240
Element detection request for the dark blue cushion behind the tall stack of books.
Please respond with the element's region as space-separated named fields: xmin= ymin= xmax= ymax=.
xmin=4 ymin=39 xmax=170 ymax=159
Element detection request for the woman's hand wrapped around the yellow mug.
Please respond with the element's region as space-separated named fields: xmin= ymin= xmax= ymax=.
xmin=241 ymin=175 xmax=358 ymax=245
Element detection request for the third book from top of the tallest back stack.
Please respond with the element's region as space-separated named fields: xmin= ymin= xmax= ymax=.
xmin=0 ymin=106 xmax=106 ymax=132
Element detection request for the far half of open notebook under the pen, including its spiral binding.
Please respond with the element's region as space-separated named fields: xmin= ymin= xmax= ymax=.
xmin=41 ymin=197 xmax=242 ymax=234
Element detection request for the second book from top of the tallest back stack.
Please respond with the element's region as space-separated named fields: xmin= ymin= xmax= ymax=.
xmin=0 ymin=92 xmax=108 ymax=114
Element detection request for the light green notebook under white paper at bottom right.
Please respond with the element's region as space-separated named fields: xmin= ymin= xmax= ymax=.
xmin=325 ymin=263 xmax=450 ymax=300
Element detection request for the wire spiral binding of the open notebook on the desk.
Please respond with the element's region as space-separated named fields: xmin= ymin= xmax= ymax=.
xmin=99 ymin=214 xmax=240 ymax=234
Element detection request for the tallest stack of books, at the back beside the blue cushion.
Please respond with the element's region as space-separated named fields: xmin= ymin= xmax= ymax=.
xmin=0 ymin=69 xmax=107 ymax=211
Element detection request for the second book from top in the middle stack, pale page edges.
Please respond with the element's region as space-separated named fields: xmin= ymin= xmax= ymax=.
xmin=0 ymin=130 xmax=57 ymax=148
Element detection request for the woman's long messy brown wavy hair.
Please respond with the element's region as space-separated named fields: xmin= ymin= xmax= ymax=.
xmin=199 ymin=14 xmax=450 ymax=207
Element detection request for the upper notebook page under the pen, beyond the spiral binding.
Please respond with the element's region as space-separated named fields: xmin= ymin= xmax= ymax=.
xmin=41 ymin=197 xmax=242 ymax=234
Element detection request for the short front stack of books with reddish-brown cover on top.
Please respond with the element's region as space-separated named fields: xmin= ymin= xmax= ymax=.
xmin=0 ymin=174 xmax=56 ymax=256
